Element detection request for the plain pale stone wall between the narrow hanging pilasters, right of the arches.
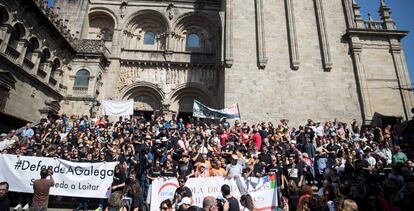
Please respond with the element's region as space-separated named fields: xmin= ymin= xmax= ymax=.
xmin=225 ymin=0 xmax=361 ymax=124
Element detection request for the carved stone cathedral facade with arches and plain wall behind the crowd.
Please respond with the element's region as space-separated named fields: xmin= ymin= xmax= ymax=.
xmin=0 ymin=0 xmax=413 ymax=129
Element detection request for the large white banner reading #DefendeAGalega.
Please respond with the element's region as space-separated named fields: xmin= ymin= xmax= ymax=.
xmin=0 ymin=154 xmax=117 ymax=198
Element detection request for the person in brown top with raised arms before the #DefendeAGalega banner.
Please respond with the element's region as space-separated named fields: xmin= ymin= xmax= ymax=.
xmin=30 ymin=168 xmax=55 ymax=211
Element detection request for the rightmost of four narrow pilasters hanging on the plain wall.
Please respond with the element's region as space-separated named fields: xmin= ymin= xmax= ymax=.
xmin=315 ymin=0 xmax=332 ymax=72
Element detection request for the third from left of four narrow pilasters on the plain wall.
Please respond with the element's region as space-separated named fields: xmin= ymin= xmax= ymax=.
xmin=285 ymin=0 xmax=300 ymax=70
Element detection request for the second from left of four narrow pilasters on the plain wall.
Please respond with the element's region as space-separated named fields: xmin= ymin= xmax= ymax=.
xmin=256 ymin=0 xmax=267 ymax=69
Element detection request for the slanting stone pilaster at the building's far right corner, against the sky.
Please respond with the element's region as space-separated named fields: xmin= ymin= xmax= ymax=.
xmin=390 ymin=38 xmax=413 ymax=120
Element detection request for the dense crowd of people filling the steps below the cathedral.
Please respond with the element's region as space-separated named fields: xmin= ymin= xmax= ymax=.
xmin=0 ymin=115 xmax=414 ymax=211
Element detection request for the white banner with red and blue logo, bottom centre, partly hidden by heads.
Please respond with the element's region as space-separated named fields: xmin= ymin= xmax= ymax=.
xmin=150 ymin=177 xmax=278 ymax=211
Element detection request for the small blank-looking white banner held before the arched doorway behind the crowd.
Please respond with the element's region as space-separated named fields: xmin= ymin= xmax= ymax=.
xmin=102 ymin=100 xmax=134 ymax=116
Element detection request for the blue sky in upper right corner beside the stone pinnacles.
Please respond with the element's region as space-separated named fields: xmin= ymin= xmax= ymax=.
xmin=357 ymin=0 xmax=414 ymax=84
